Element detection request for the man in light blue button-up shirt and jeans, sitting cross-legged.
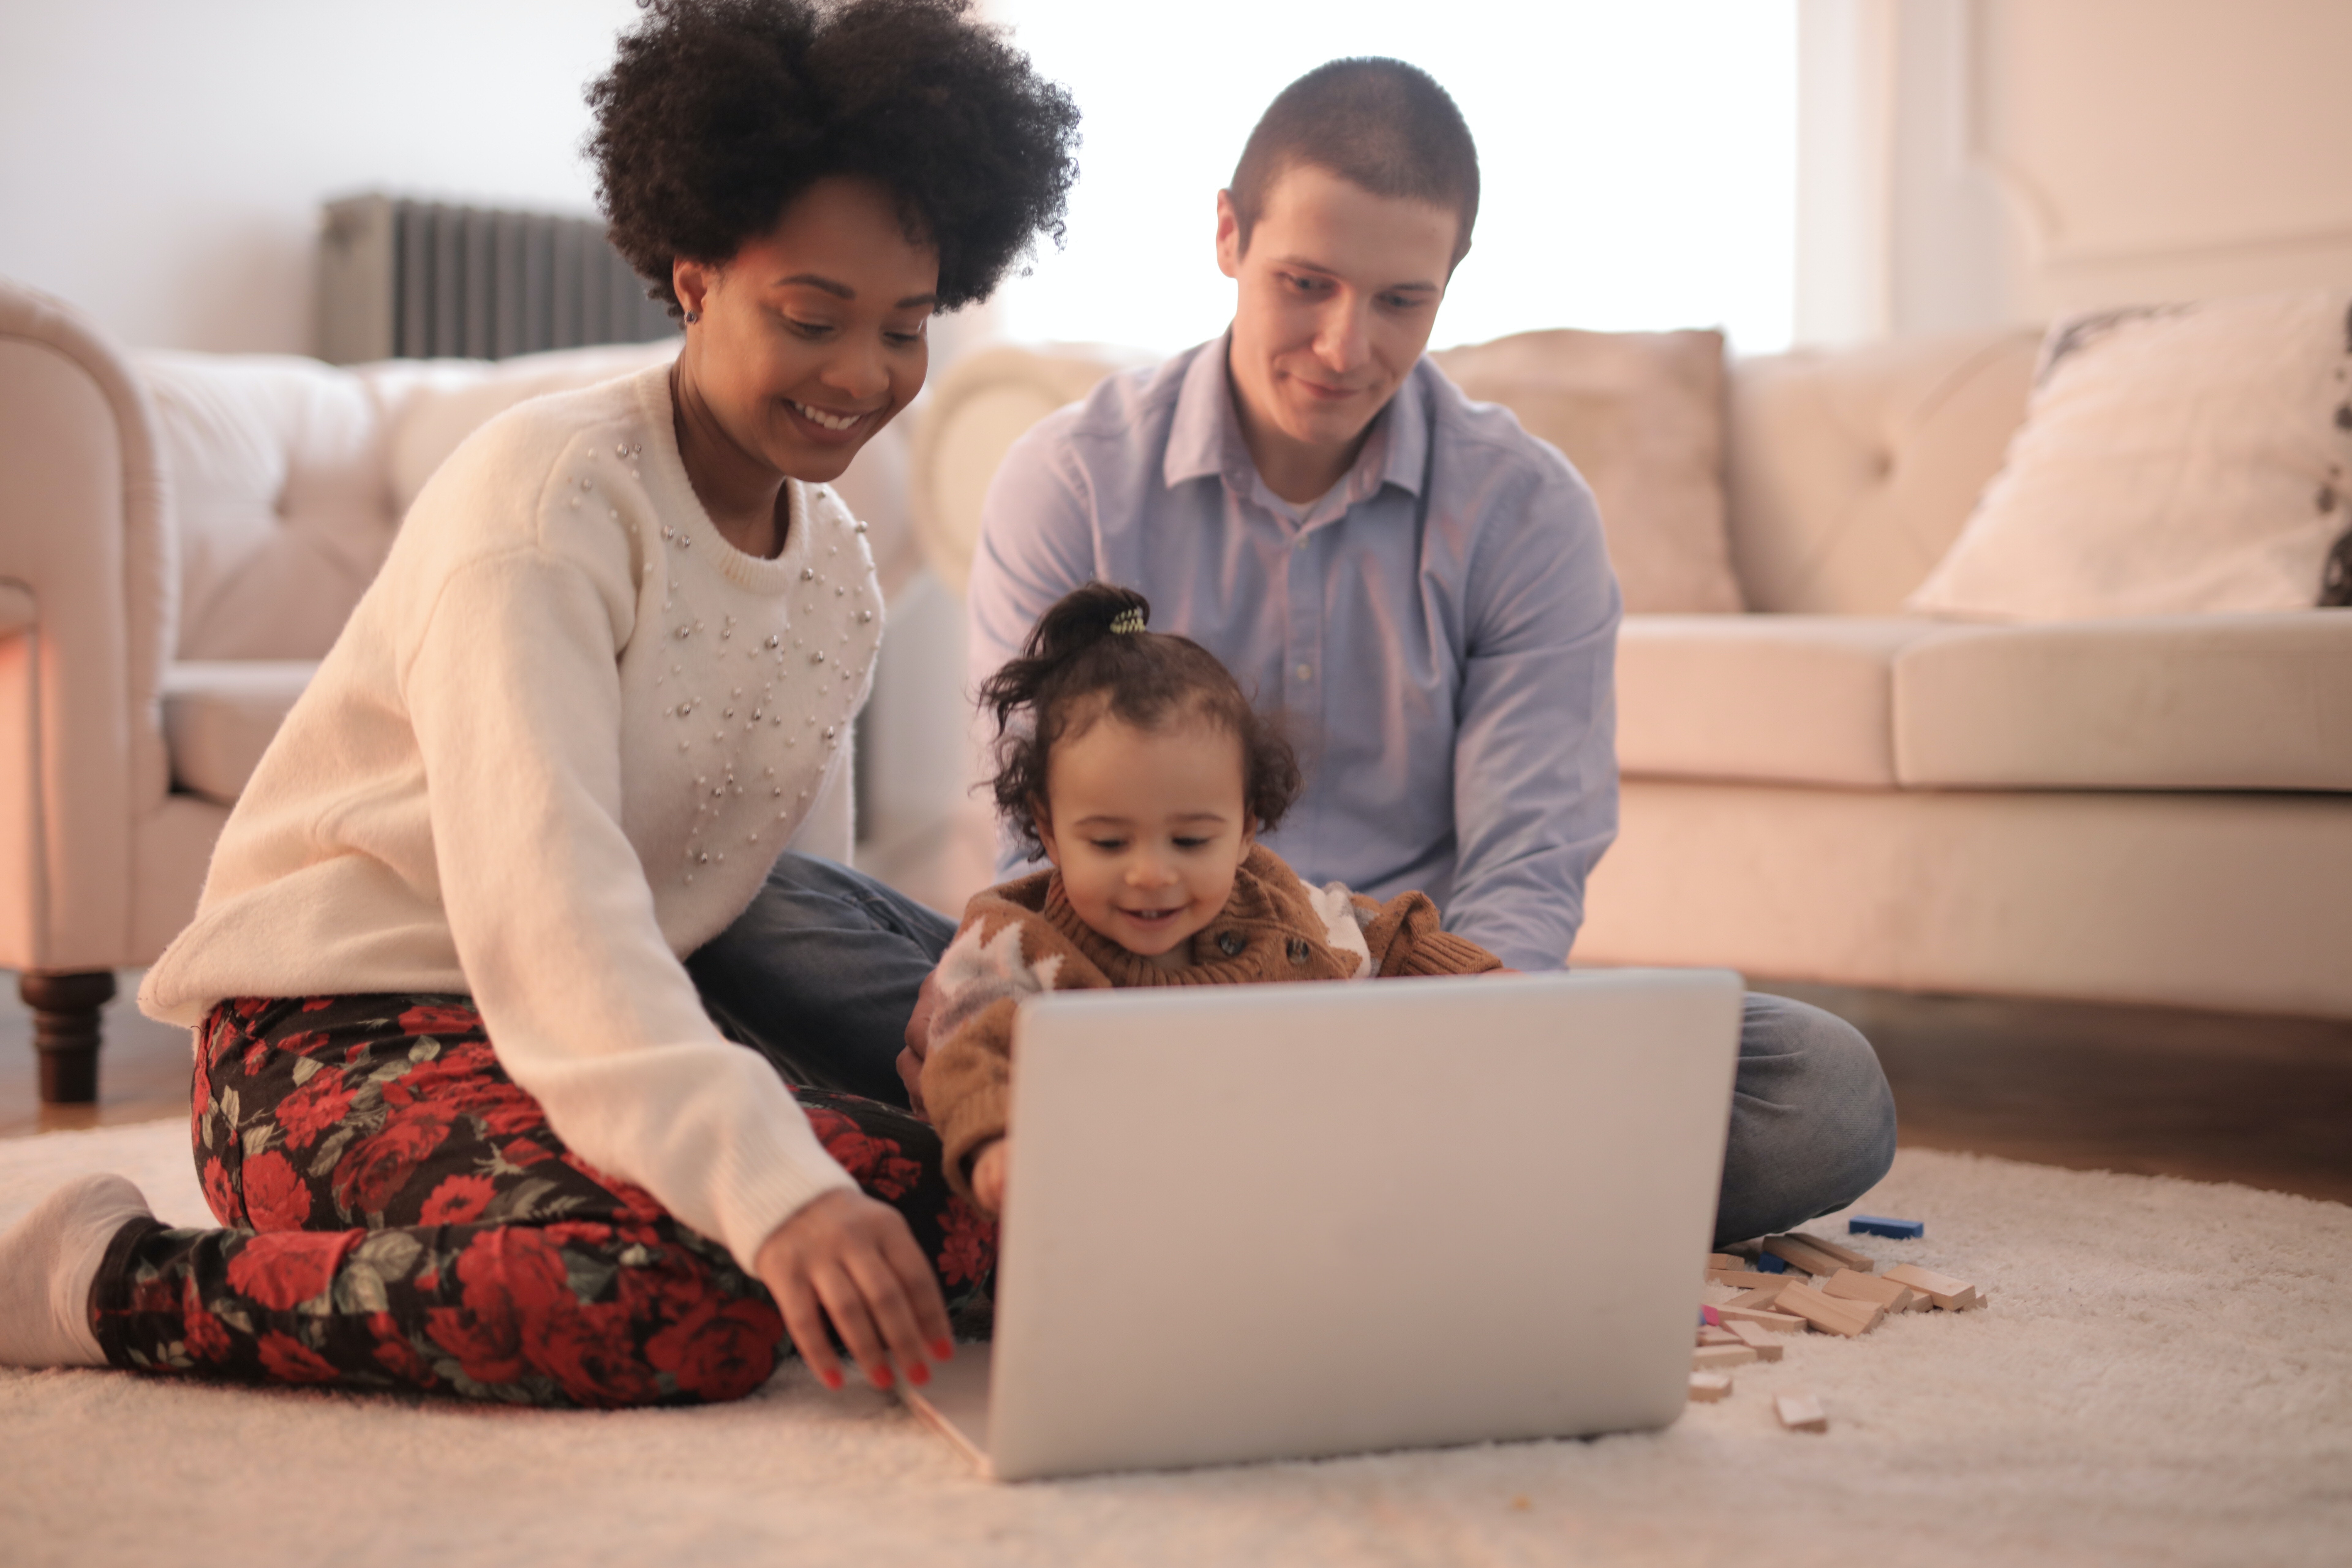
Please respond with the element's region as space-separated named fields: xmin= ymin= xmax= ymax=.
xmin=696 ymin=59 xmax=1893 ymax=1241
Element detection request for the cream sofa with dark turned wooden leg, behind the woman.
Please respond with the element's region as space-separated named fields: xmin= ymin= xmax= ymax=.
xmin=0 ymin=280 xmax=917 ymax=1100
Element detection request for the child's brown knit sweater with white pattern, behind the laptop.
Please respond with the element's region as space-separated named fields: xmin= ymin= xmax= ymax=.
xmin=922 ymin=846 xmax=1503 ymax=1197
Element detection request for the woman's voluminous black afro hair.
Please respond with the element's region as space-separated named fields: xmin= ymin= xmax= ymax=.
xmin=588 ymin=0 xmax=1077 ymax=315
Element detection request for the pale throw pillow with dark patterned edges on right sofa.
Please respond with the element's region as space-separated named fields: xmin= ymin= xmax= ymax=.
xmin=1907 ymin=289 xmax=2352 ymax=621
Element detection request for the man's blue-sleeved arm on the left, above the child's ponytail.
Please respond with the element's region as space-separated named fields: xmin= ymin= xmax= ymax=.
xmin=964 ymin=409 xmax=1096 ymax=879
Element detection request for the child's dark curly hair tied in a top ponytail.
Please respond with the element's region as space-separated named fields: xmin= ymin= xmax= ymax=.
xmin=981 ymin=583 xmax=1301 ymax=856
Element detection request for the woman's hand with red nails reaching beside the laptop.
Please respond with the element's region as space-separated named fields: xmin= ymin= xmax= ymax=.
xmin=757 ymin=1187 xmax=955 ymax=1389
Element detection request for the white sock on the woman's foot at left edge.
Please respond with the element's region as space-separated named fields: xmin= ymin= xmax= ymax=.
xmin=0 ymin=1175 xmax=155 ymax=1366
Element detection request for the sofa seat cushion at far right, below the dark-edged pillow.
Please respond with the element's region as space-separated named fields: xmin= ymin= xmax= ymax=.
xmin=1893 ymin=609 xmax=2352 ymax=790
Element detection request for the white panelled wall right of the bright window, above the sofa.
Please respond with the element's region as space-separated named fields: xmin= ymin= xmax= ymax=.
xmin=1797 ymin=0 xmax=2352 ymax=343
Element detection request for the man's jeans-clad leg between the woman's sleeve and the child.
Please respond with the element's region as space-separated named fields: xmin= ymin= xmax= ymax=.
xmin=687 ymin=853 xmax=955 ymax=1105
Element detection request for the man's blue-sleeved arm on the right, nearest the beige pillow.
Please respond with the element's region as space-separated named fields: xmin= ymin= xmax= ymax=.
xmin=1446 ymin=454 xmax=1623 ymax=969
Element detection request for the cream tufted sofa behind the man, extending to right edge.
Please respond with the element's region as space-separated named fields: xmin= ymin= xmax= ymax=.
xmin=913 ymin=331 xmax=2352 ymax=1018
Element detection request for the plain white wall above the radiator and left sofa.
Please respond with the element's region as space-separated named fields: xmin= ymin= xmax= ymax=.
xmin=0 ymin=0 xmax=637 ymax=352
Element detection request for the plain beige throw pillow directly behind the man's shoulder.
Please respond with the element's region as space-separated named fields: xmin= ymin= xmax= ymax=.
xmin=1430 ymin=331 xmax=1740 ymax=613
